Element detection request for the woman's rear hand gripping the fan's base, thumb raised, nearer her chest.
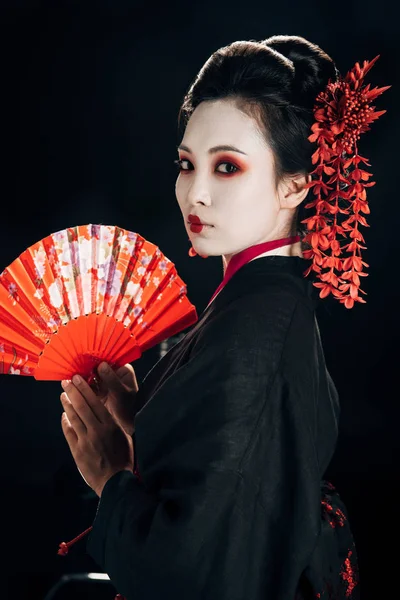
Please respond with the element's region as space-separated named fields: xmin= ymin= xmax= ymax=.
xmin=95 ymin=362 xmax=139 ymax=435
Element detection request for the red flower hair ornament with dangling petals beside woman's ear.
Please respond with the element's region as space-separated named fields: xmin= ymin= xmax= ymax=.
xmin=189 ymin=55 xmax=392 ymax=308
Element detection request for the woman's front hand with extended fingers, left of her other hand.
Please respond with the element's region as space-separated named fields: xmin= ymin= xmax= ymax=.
xmin=60 ymin=377 xmax=134 ymax=497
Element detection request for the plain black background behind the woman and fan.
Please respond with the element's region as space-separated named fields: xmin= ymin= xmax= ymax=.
xmin=0 ymin=0 xmax=400 ymax=600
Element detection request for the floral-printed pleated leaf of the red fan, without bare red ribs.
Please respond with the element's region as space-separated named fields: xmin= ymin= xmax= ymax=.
xmin=0 ymin=224 xmax=197 ymax=374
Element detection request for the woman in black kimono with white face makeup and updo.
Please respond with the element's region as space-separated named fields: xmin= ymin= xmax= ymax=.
xmin=63 ymin=36 xmax=359 ymax=600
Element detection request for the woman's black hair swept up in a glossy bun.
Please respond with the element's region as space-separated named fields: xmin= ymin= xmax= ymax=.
xmin=178 ymin=35 xmax=340 ymax=239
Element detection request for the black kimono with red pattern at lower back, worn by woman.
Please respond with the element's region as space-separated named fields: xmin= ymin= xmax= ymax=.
xmin=87 ymin=255 xmax=359 ymax=600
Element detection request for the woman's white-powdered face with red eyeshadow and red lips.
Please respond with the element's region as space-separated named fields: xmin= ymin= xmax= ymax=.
xmin=175 ymin=100 xmax=293 ymax=261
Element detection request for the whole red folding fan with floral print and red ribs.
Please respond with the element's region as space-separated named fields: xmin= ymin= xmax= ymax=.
xmin=0 ymin=224 xmax=198 ymax=383
